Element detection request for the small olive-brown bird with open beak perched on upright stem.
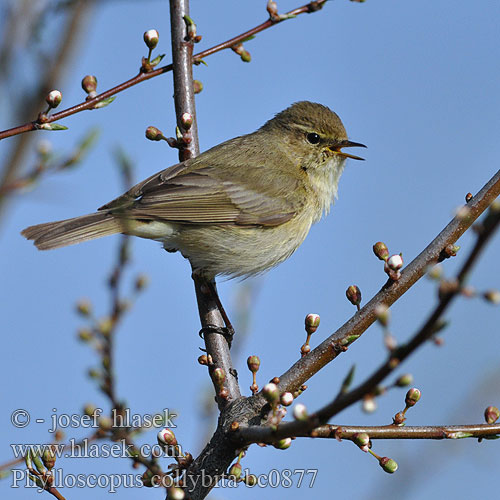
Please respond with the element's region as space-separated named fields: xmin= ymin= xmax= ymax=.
xmin=22 ymin=101 xmax=366 ymax=280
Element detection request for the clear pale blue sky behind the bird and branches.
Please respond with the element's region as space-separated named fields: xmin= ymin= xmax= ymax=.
xmin=0 ymin=0 xmax=500 ymax=500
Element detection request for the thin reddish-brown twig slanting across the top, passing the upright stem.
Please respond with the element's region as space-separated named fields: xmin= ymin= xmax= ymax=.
xmin=0 ymin=0 xmax=327 ymax=140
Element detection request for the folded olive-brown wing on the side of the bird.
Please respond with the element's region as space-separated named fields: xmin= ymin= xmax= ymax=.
xmin=99 ymin=163 xmax=297 ymax=226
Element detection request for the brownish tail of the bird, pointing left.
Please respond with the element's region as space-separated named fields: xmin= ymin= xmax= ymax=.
xmin=21 ymin=212 xmax=123 ymax=250
